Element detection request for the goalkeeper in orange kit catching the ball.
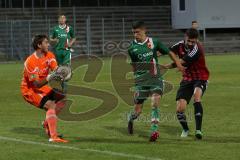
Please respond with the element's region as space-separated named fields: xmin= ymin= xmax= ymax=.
xmin=21 ymin=35 xmax=68 ymax=143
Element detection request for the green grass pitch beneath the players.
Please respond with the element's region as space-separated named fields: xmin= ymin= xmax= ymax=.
xmin=0 ymin=55 xmax=240 ymax=160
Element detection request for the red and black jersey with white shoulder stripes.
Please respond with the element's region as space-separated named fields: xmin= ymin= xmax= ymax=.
xmin=170 ymin=40 xmax=209 ymax=81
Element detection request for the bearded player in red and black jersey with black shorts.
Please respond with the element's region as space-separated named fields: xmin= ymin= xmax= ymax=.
xmin=165 ymin=28 xmax=209 ymax=139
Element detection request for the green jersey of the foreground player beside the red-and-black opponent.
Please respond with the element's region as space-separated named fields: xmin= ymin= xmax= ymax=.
xmin=128 ymin=37 xmax=169 ymax=80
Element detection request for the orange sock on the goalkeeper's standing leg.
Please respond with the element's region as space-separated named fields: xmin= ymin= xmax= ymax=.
xmin=46 ymin=109 xmax=57 ymax=137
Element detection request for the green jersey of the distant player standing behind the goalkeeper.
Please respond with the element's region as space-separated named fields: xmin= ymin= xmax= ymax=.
xmin=51 ymin=25 xmax=75 ymax=50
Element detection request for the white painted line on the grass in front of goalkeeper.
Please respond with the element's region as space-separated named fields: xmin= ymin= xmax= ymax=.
xmin=0 ymin=136 xmax=163 ymax=160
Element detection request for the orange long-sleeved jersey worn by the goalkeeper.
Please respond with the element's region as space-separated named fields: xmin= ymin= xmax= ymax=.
xmin=21 ymin=52 xmax=57 ymax=95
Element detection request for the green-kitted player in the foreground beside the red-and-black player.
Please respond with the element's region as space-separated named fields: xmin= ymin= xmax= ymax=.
xmin=128 ymin=21 xmax=184 ymax=141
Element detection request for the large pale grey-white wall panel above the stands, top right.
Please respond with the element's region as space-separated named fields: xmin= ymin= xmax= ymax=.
xmin=171 ymin=0 xmax=240 ymax=29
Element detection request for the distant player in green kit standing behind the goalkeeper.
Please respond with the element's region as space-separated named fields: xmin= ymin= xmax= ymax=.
xmin=50 ymin=15 xmax=76 ymax=65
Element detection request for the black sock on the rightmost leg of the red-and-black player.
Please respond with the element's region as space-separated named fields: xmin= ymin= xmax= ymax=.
xmin=193 ymin=102 xmax=203 ymax=130
